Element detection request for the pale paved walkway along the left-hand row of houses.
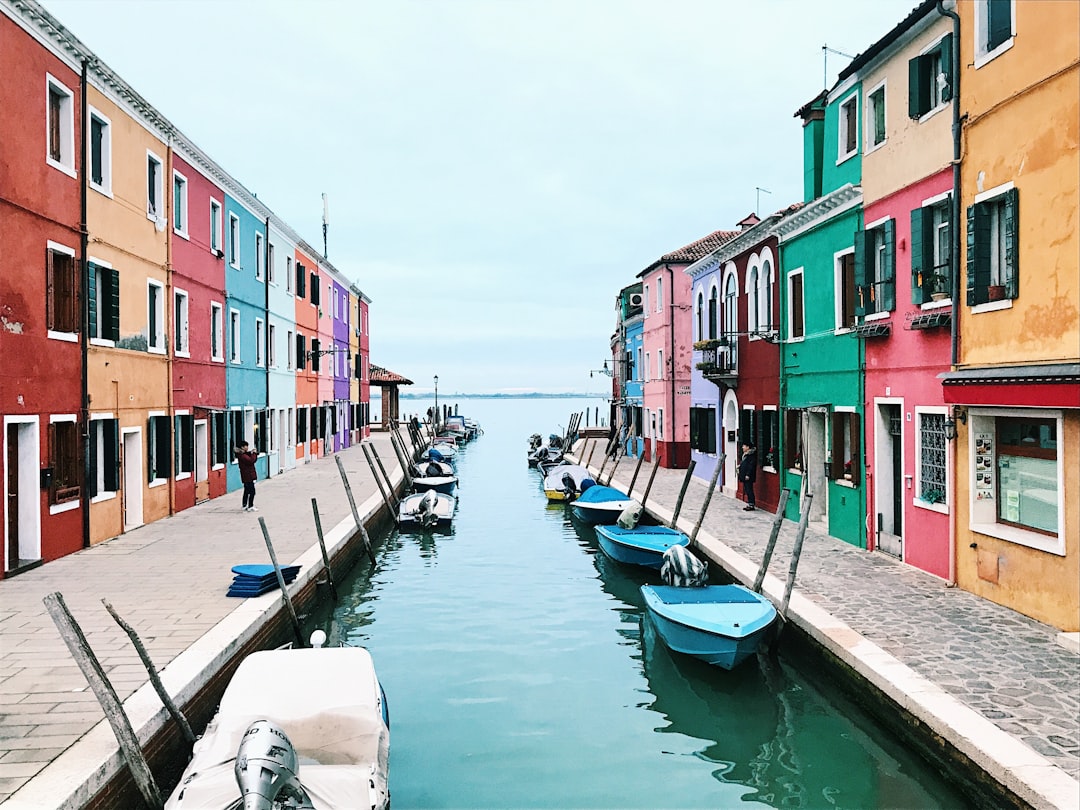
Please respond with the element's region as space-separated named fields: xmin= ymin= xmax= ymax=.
xmin=0 ymin=433 xmax=399 ymax=804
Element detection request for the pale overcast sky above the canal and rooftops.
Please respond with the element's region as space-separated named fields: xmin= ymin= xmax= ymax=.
xmin=42 ymin=0 xmax=916 ymax=394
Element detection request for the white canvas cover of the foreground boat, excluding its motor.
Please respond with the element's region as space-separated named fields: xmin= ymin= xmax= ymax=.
xmin=165 ymin=647 xmax=390 ymax=810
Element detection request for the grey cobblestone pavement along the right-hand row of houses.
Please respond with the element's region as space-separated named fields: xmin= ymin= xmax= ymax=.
xmin=581 ymin=438 xmax=1080 ymax=779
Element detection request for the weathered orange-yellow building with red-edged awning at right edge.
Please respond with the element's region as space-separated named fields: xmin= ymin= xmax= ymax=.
xmin=943 ymin=0 xmax=1080 ymax=632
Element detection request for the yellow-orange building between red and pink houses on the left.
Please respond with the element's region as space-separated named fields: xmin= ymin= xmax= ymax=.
xmin=86 ymin=65 xmax=174 ymax=543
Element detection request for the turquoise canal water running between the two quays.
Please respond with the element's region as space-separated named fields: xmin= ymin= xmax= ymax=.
xmin=308 ymin=399 xmax=968 ymax=810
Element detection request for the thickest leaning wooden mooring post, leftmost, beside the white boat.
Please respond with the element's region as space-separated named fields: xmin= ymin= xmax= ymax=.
xmin=42 ymin=591 xmax=164 ymax=810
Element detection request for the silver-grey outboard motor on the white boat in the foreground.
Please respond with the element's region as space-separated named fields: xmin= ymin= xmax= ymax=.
xmin=232 ymin=720 xmax=310 ymax=810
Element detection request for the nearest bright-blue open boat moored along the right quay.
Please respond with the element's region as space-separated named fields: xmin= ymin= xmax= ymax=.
xmin=642 ymin=585 xmax=777 ymax=670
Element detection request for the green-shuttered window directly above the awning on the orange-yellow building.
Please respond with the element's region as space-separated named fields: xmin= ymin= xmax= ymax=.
xmin=968 ymin=188 xmax=1020 ymax=307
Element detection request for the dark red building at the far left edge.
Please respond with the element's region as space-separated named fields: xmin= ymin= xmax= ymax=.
xmin=0 ymin=15 xmax=84 ymax=576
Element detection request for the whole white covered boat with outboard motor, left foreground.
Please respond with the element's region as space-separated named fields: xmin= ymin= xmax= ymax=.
xmin=165 ymin=647 xmax=390 ymax=810
